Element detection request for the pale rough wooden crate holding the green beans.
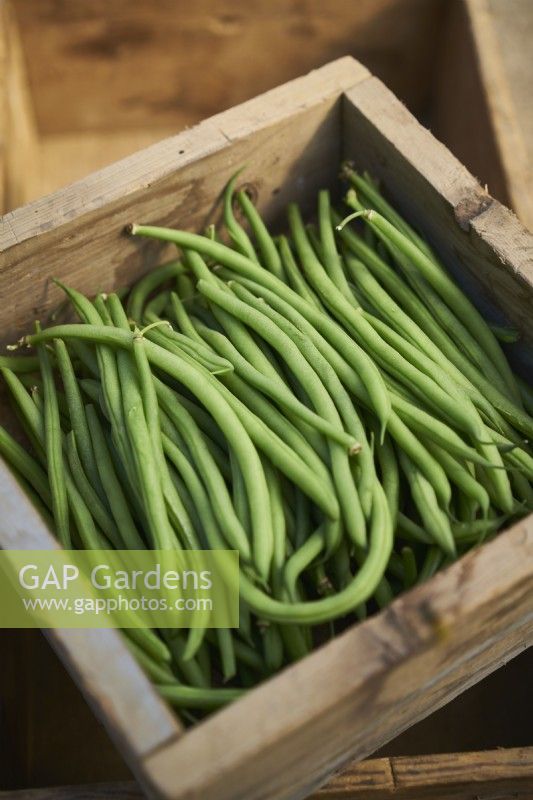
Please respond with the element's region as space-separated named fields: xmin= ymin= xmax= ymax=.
xmin=0 ymin=58 xmax=533 ymax=800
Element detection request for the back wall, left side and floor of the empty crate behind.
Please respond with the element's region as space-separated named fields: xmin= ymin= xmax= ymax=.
xmin=0 ymin=0 xmax=444 ymax=211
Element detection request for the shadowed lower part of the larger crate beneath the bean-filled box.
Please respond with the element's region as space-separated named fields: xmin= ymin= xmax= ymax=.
xmin=0 ymin=631 xmax=533 ymax=800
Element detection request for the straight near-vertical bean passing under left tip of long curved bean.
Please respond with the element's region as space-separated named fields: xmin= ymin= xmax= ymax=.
xmin=37 ymin=327 xmax=71 ymax=548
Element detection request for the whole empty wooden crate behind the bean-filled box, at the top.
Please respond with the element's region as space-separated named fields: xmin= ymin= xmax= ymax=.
xmin=0 ymin=0 xmax=533 ymax=234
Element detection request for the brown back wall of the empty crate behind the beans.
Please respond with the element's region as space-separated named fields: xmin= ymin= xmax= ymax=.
xmin=12 ymin=0 xmax=444 ymax=135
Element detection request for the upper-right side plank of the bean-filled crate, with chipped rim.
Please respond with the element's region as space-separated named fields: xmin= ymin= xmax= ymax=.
xmin=343 ymin=79 xmax=533 ymax=363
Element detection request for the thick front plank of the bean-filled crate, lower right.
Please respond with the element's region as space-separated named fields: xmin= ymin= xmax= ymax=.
xmin=144 ymin=519 xmax=533 ymax=800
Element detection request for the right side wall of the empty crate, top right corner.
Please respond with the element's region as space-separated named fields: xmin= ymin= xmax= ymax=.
xmin=432 ymin=0 xmax=533 ymax=230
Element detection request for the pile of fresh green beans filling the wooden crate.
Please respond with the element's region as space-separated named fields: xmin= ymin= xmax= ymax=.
xmin=0 ymin=165 xmax=533 ymax=721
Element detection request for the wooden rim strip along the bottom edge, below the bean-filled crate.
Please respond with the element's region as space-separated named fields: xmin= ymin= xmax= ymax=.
xmin=4 ymin=747 xmax=533 ymax=800
